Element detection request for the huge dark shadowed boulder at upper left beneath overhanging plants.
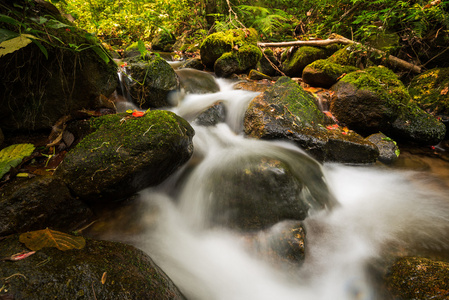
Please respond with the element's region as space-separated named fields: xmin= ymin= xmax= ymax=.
xmin=0 ymin=30 xmax=117 ymax=132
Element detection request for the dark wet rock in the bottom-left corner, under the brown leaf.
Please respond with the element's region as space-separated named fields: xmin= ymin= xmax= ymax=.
xmin=0 ymin=235 xmax=185 ymax=300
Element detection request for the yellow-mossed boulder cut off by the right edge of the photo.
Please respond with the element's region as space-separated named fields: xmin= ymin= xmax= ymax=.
xmin=409 ymin=68 xmax=449 ymax=116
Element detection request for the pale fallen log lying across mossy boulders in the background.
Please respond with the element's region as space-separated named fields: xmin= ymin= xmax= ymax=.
xmin=257 ymin=36 xmax=421 ymax=73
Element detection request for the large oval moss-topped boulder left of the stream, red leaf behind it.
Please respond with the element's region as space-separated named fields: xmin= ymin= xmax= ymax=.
xmin=55 ymin=111 xmax=194 ymax=201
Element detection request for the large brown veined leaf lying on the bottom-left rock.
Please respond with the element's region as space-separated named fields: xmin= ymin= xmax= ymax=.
xmin=19 ymin=228 xmax=86 ymax=251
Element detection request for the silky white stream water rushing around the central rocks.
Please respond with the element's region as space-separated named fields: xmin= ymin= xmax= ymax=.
xmin=94 ymin=74 xmax=449 ymax=300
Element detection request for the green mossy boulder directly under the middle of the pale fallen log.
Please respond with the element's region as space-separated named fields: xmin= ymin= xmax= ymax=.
xmin=281 ymin=46 xmax=329 ymax=77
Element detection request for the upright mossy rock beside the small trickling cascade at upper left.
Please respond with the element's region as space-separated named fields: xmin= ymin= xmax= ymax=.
xmin=123 ymin=55 xmax=179 ymax=109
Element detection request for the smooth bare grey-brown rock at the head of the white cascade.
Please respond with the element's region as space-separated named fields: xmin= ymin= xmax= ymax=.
xmin=176 ymin=69 xmax=220 ymax=94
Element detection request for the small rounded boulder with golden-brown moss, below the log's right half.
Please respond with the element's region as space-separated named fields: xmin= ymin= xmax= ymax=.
xmin=302 ymin=59 xmax=357 ymax=88
